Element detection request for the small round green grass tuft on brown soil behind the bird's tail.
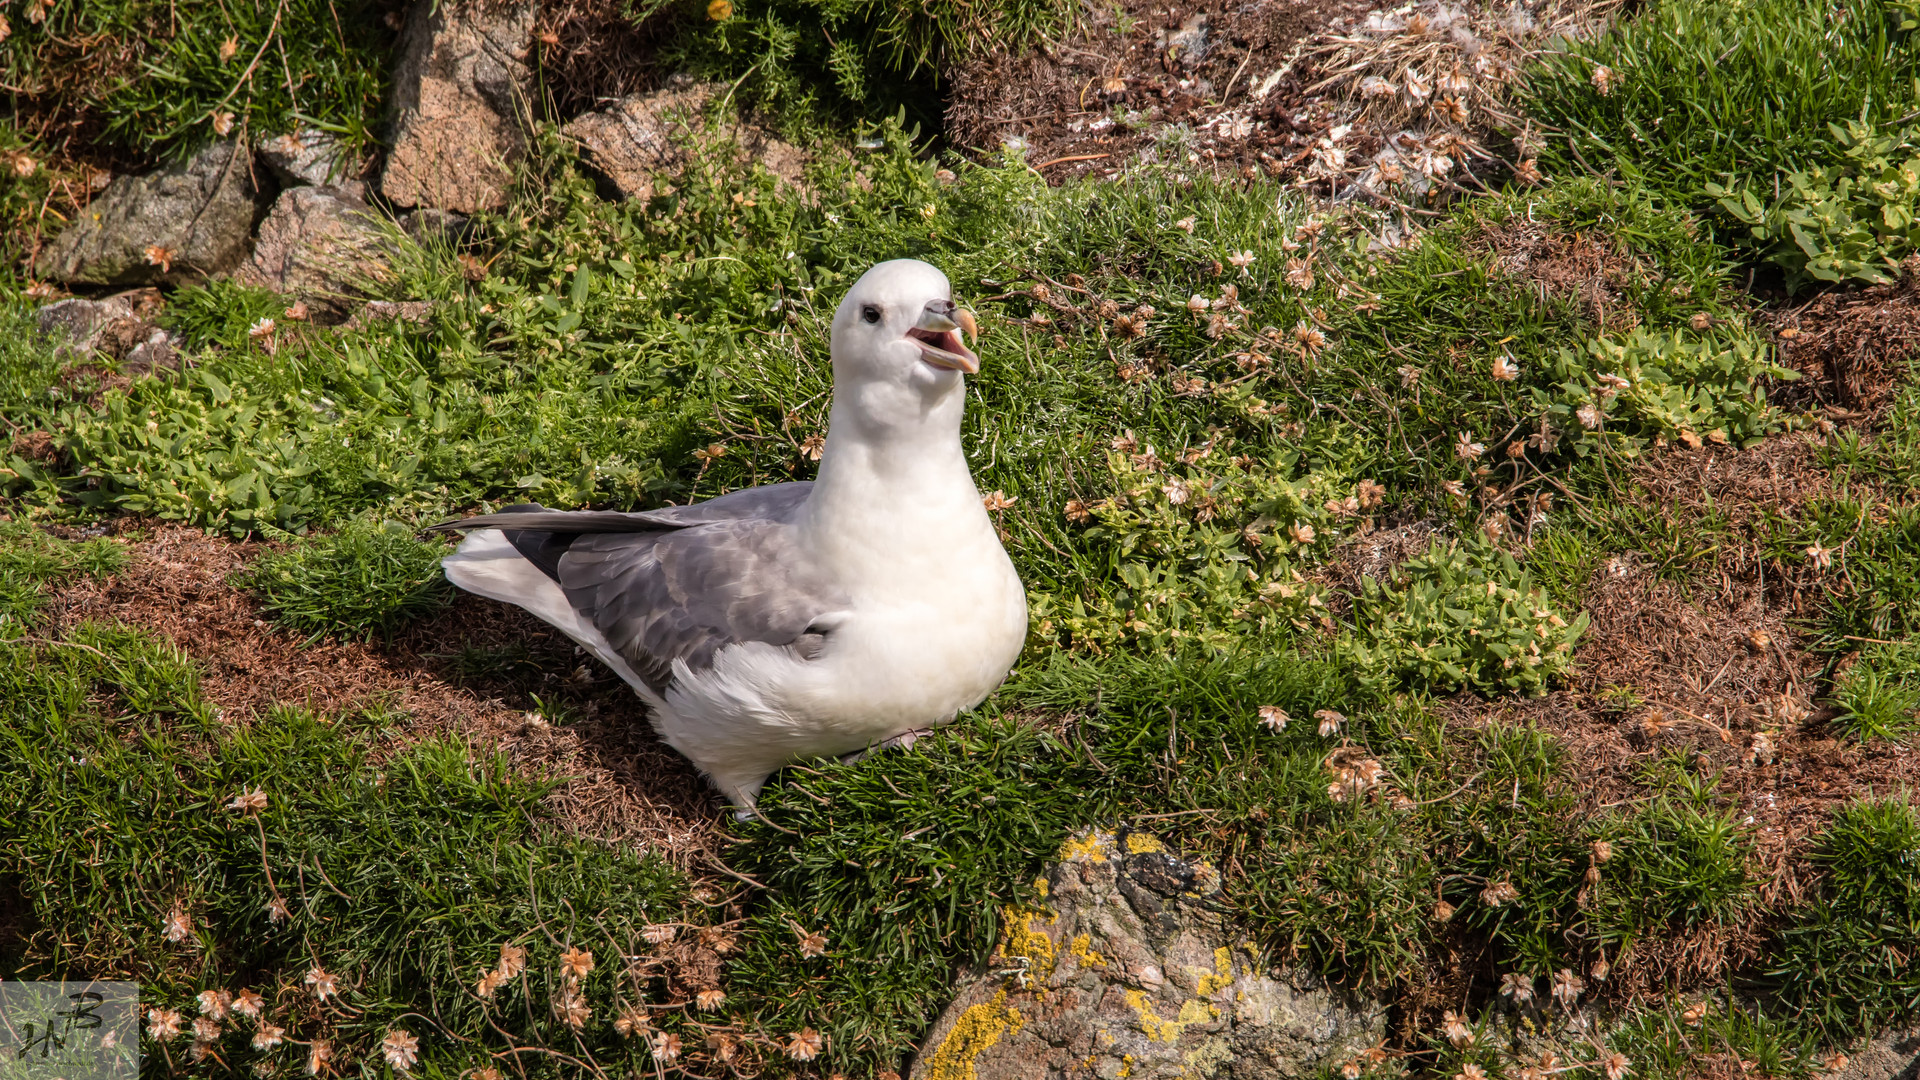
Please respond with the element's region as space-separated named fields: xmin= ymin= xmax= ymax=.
xmin=240 ymin=521 xmax=453 ymax=638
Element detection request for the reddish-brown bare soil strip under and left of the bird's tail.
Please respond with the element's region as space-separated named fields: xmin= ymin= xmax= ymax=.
xmin=48 ymin=521 xmax=722 ymax=869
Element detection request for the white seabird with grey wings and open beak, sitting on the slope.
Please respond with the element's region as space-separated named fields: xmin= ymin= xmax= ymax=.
xmin=436 ymin=259 xmax=1027 ymax=815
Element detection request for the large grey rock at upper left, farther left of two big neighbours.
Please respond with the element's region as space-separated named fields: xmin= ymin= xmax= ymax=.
xmin=35 ymin=142 xmax=259 ymax=284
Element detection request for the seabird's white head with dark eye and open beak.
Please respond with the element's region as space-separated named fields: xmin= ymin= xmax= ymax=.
xmin=833 ymin=259 xmax=979 ymax=394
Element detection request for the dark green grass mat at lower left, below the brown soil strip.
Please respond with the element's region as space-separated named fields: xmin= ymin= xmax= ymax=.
xmin=0 ymin=625 xmax=707 ymax=1074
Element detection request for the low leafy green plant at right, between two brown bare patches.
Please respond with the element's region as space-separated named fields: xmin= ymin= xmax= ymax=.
xmin=1534 ymin=329 xmax=1799 ymax=454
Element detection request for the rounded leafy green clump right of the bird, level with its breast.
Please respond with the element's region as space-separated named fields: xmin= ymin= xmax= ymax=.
xmin=1342 ymin=542 xmax=1588 ymax=696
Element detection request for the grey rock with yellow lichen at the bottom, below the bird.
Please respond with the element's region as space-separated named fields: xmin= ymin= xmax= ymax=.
xmin=912 ymin=832 xmax=1386 ymax=1080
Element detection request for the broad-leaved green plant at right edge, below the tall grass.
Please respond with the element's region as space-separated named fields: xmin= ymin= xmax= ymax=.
xmin=1707 ymin=119 xmax=1920 ymax=286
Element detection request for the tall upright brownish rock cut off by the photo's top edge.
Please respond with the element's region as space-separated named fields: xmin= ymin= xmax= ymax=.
xmin=380 ymin=0 xmax=540 ymax=213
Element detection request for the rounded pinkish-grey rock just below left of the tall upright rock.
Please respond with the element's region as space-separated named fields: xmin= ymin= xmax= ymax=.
xmin=234 ymin=186 xmax=394 ymax=313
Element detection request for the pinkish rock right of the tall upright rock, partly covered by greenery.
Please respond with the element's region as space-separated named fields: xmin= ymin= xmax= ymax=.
xmin=561 ymin=83 xmax=806 ymax=200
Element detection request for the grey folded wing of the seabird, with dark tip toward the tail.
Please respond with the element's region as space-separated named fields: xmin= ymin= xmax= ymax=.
xmin=436 ymin=482 xmax=847 ymax=694
